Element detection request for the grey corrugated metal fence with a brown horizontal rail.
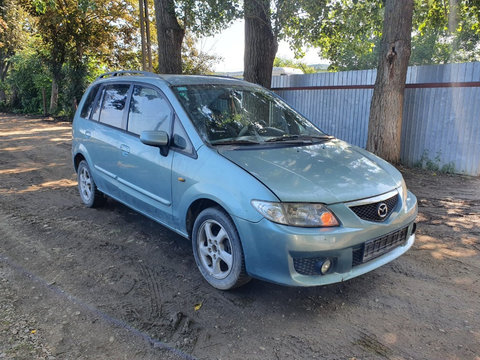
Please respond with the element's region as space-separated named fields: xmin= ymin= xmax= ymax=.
xmin=272 ymin=63 xmax=480 ymax=176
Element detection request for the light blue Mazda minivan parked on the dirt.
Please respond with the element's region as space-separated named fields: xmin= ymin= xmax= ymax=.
xmin=72 ymin=71 xmax=417 ymax=289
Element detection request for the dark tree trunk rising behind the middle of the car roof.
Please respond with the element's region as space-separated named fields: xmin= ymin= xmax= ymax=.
xmin=154 ymin=0 xmax=185 ymax=74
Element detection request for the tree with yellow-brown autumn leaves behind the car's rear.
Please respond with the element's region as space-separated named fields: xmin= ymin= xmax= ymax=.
xmin=20 ymin=0 xmax=139 ymax=113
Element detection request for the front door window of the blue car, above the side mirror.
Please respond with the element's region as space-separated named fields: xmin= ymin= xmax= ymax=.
xmin=127 ymin=86 xmax=172 ymax=135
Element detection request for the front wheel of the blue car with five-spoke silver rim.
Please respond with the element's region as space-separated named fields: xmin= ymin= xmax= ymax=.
xmin=192 ymin=207 xmax=250 ymax=290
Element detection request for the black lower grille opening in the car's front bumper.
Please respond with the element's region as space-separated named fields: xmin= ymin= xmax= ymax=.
xmin=352 ymin=226 xmax=408 ymax=266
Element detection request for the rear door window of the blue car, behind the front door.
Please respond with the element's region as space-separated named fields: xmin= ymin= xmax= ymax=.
xmin=100 ymin=84 xmax=130 ymax=128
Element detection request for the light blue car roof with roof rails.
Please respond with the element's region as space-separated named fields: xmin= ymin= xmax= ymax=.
xmin=96 ymin=70 xmax=254 ymax=86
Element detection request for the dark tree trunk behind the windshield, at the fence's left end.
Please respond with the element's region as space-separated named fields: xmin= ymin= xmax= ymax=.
xmin=243 ymin=0 xmax=278 ymax=88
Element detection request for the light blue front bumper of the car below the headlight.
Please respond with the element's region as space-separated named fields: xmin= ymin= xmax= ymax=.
xmin=235 ymin=193 xmax=417 ymax=286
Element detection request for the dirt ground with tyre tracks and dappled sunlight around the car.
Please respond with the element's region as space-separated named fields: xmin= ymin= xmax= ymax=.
xmin=0 ymin=114 xmax=480 ymax=360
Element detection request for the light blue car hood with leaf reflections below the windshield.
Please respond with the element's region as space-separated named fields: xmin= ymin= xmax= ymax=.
xmin=218 ymin=139 xmax=402 ymax=204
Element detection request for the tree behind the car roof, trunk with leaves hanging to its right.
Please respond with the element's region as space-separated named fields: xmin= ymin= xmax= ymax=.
xmin=154 ymin=0 xmax=240 ymax=74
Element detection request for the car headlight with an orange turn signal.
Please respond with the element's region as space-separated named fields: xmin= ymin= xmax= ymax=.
xmin=252 ymin=200 xmax=339 ymax=227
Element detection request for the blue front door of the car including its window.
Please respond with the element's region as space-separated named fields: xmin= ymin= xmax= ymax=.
xmin=117 ymin=84 xmax=174 ymax=224
